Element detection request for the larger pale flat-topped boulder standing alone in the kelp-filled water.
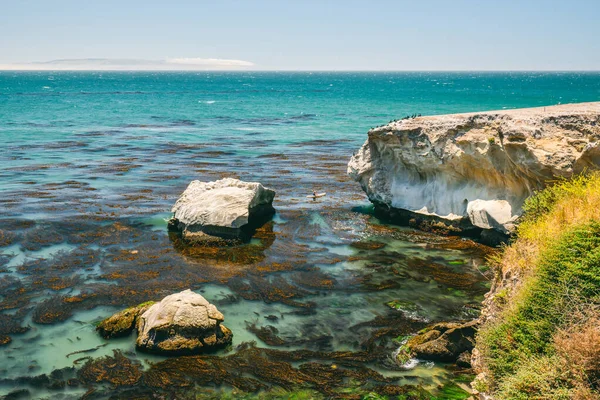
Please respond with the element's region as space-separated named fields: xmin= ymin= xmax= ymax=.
xmin=169 ymin=178 xmax=275 ymax=242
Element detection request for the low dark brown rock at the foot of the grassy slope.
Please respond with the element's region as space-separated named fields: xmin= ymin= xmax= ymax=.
xmin=406 ymin=321 xmax=478 ymax=363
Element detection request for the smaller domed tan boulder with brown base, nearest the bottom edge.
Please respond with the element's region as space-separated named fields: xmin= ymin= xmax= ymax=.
xmin=136 ymin=289 xmax=233 ymax=355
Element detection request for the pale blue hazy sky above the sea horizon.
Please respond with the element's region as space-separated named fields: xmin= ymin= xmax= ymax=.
xmin=0 ymin=0 xmax=600 ymax=71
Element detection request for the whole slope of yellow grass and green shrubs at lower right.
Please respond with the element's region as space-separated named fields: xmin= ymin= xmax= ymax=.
xmin=474 ymin=173 xmax=600 ymax=399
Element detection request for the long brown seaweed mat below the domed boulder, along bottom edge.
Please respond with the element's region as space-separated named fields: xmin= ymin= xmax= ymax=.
xmin=129 ymin=343 xmax=404 ymax=397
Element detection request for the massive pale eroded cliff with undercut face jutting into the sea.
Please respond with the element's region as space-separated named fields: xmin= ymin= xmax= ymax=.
xmin=348 ymin=102 xmax=600 ymax=238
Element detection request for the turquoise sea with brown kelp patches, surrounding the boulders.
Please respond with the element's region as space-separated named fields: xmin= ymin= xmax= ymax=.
xmin=0 ymin=72 xmax=600 ymax=398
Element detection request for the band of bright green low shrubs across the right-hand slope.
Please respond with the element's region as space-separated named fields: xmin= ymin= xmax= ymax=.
xmin=478 ymin=222 xmax=600 ymax=380
